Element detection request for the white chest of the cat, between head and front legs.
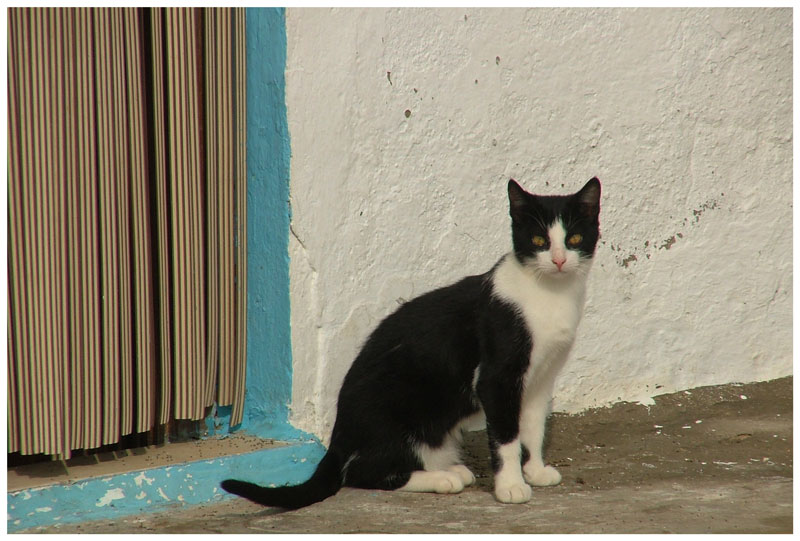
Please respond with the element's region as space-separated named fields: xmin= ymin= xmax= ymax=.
xmin=494 ymin=256 xmax=586 ymax=376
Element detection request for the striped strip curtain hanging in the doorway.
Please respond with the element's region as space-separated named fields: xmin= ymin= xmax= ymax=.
xmin=8 ymin=8 xmax=247 ymax=458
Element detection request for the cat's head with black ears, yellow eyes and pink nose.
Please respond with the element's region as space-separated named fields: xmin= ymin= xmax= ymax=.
xmin=508 ymin=177 xmax=600 ymax=279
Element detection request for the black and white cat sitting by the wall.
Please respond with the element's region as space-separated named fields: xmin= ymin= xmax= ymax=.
xmin=222 ymin=178 xmax=600 ymax=509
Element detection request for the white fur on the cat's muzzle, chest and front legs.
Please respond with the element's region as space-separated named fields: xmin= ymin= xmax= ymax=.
xmin=494 ymin=217 xmax=591 ymax=496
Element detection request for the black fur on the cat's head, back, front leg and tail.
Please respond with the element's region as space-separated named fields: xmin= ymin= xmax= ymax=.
xmin=222 ymin=179 xmax=599 ymax=509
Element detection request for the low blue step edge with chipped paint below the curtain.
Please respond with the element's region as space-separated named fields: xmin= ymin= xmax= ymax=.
xmin=6 ymin=441 xmax=325 ymax=533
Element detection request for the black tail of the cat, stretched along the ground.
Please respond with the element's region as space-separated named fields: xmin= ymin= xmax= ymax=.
xmin=221 ymin=449 xmax=343 ymax=509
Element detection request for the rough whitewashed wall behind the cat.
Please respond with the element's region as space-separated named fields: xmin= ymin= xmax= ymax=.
xmin=286 ymin=9 xmax=792 ymax=438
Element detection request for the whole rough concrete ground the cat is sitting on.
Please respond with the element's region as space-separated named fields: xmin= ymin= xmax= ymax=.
xmin=20 ymin=378 xmax=793 ymax=533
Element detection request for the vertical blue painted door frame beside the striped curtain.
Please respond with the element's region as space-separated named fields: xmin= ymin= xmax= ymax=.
xmin=242 ymin=8 xmax=308 ymax=439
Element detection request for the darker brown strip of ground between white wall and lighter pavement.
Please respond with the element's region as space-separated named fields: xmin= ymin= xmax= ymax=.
xmin=466 ymin=378 xmax=792 ymax=490
